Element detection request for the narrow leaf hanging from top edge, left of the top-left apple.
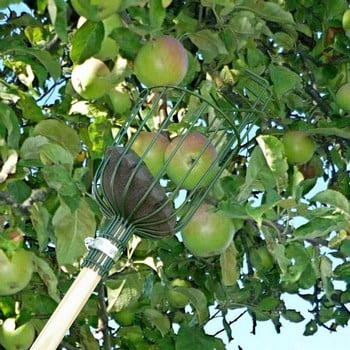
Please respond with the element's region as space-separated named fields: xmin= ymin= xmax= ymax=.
xmin=47 ymin=0 xmax=68 ymax=42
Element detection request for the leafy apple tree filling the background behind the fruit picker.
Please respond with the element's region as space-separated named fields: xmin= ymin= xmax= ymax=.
xmin=0 ymin=0 xmax=350 ymax=350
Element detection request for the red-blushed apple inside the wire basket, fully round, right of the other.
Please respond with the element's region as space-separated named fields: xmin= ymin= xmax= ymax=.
xmin=164 ymin=131 xmax=218 ymax=190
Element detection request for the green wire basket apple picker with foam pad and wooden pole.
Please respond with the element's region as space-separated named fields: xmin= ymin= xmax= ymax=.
xmin=31 ymin=72 xmax=271 ymax=350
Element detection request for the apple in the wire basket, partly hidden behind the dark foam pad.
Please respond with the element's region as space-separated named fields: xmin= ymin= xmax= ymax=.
xmin=131 ymin=131 xmax=170 ymax=176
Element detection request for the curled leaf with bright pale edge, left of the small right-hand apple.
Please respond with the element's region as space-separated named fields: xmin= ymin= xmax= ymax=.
xmin=256 ymin=135 xmax=288 ymax=191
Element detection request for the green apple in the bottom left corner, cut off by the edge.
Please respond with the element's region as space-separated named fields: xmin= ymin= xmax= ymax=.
xmin=0 ymin=318 xmax=35 ymax=350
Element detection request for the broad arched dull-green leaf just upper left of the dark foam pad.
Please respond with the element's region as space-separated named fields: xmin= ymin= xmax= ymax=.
xmin=33 ymin=119 xmax=81 ymax=158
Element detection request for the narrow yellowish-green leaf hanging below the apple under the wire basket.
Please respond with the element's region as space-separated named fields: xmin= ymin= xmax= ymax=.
xmin=220 ymin=242 xmax=240 ymax=286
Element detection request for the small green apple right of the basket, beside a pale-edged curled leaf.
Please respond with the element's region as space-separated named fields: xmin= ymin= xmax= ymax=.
xmin=282 ymin=131 xmax=316 ymax=164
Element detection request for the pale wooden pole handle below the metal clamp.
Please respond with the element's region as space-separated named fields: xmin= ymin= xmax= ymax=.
xmin=30 ymin=267 xmax=101 ymax=350
